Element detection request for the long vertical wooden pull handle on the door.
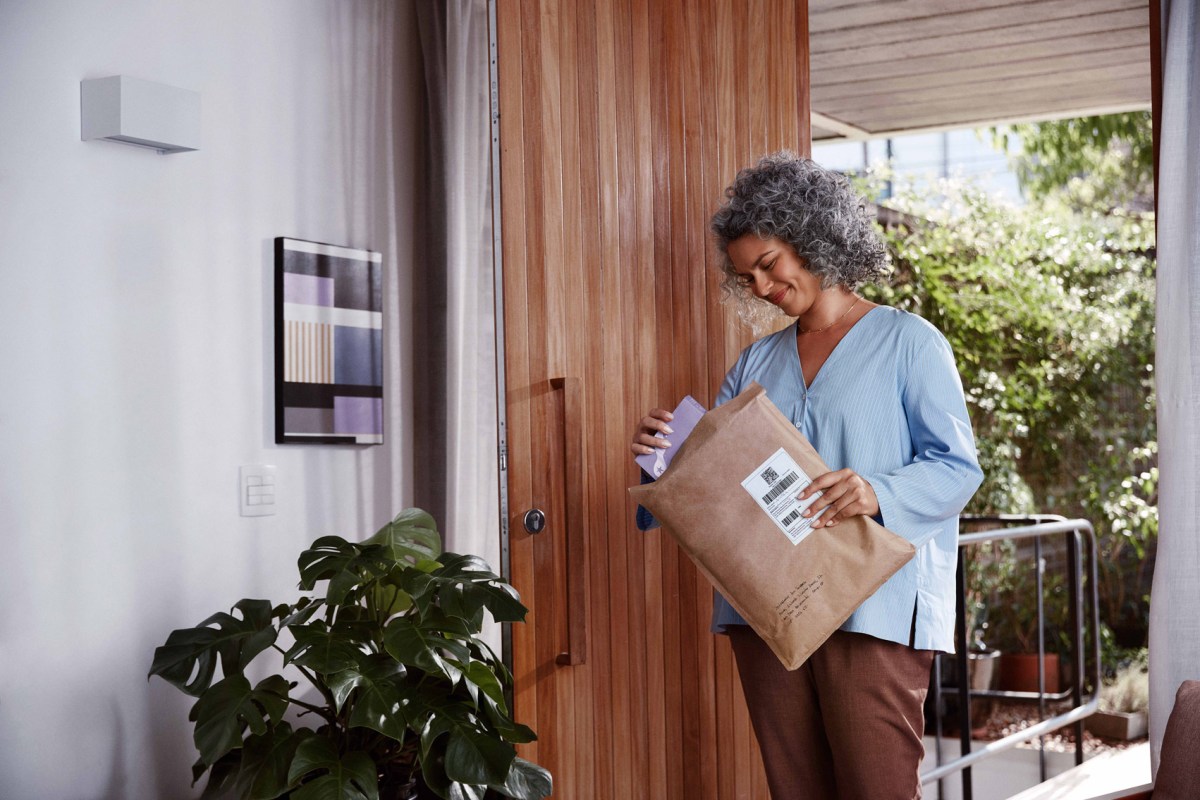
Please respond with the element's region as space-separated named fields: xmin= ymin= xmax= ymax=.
xmin=550 ymin=378 xmax=588 ymax=667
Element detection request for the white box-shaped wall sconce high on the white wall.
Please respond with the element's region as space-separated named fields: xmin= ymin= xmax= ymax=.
xmin=79 ymin=76 xmax=200 ymax=155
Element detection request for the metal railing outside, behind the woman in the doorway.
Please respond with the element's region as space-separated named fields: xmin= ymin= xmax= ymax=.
xmin=920 ymin=515 xmax=1100 ymax=800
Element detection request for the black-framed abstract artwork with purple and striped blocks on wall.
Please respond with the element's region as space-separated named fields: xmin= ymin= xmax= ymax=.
xmin=275 ymin=236 xmax=383 ymax=445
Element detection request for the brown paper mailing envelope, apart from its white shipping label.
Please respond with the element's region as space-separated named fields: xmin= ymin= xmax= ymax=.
xmin=629 ymin=384 xmax=916 ymax=669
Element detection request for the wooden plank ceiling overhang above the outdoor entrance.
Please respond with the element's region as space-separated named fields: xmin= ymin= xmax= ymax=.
xmin=809 ymin=0 xmax=1151 ymax=142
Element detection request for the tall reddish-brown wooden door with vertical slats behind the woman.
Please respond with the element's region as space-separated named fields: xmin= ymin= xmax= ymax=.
xmin=497 ymin=0 xmax=810 ymax=800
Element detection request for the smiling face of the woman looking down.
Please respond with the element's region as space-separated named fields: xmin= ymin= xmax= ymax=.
xmin=726 ymin=234 xmax=821 ymax=317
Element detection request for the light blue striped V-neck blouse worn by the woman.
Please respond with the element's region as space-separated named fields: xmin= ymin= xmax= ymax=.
xmin=713 ymin=306 xmax=983 ymax=652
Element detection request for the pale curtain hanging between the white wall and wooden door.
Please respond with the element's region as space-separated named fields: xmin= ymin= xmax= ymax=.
xmin=413 ymin=0 xmax=500 ymax=571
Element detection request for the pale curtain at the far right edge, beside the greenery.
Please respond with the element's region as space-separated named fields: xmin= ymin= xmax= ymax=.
xmin=1150 ymin=0 xmax=1200 ymax=772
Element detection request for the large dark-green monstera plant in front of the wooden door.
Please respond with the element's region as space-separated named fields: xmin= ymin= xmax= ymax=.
xmin=150 ymin=509 xmax=551 ymax=800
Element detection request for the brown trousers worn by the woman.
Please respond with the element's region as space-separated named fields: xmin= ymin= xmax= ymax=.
xmin=728 ymin=625 xmax=934 ymax=800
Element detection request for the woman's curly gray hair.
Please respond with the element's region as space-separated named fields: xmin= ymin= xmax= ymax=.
xmin=712 ymin=150 xmax=889 ymax=327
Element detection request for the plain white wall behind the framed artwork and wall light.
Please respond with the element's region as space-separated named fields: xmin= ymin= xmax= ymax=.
xmin=0 ymin=0 xmax=421 ymax=800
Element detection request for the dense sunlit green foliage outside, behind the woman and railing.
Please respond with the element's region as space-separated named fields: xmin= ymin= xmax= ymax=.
xmin=871 ymin=115 xmax=1158 ymax=667
